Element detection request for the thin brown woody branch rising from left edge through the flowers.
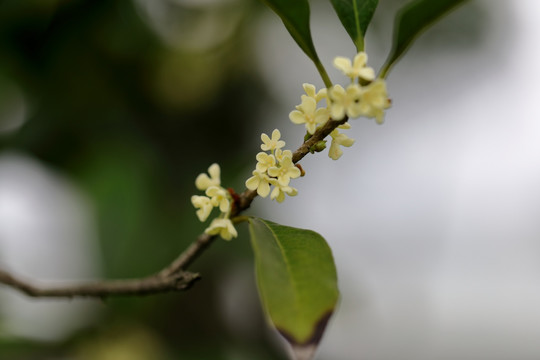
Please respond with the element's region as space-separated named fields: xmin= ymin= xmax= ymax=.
xmin=0 ymin=118 xmax=347 ymax=298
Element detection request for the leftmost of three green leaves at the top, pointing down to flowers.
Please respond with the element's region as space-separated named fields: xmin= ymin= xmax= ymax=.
xmin=262 ymin=0 xmax=332 ymax=87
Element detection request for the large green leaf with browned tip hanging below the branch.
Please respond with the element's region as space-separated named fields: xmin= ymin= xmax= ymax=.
xmin=249 ymin=218 xmax=339 ymax=359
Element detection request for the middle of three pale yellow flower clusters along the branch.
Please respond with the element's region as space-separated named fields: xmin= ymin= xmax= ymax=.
xmin=246 ymin=129 xmax=300 ymax=202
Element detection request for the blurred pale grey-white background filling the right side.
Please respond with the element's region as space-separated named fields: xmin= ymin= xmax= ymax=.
xmin=257 ymin=0 xmax=540 ymax=360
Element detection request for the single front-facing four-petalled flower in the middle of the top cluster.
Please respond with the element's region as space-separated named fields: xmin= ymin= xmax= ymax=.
xmin=328 ymin=84 xmax=362 ymax=121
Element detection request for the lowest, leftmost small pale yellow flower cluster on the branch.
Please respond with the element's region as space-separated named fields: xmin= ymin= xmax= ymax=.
xmin=191 ymin=164 xmax=238 ymax=240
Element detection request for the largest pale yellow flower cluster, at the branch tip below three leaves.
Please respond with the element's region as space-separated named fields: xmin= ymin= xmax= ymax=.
xmin=289 ymin=52 xmax=390 ymax=160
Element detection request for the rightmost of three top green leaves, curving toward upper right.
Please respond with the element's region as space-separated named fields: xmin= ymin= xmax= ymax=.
xmin=381 ymin=0 xmax=467 ymax=78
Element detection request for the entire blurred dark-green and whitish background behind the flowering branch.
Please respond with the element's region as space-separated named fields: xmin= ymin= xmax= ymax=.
xmin=0 ymin=0 xmax=540 ymax=360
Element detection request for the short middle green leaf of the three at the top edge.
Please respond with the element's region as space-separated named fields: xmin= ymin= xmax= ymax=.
xmin=330 ymin=0 xmax=379 ymax=52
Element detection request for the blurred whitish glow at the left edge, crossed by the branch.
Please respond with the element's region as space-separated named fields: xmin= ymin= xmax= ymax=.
xmin=0 ymin=153 xmax=101 ymax=341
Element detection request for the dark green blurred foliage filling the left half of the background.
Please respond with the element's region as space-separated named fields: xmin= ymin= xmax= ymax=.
xmin=0 ymin=0 xmax=292 ymax=360
